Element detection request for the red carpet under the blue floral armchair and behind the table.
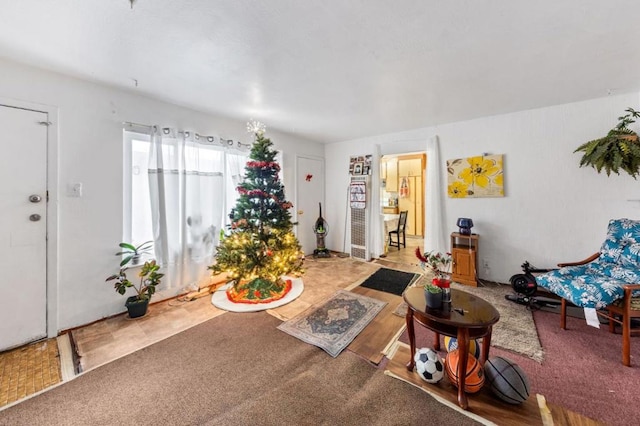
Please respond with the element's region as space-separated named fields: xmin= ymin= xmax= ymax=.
xmin=400 ymin=306 xmax=640 ymax=425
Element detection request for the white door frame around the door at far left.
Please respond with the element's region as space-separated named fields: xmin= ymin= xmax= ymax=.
xmin=0 ymin=97 xmax=59 ymax=338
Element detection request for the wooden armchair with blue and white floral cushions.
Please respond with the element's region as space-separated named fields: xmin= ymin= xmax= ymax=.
xmin=536 ymin=219 xmax=640 ymax=366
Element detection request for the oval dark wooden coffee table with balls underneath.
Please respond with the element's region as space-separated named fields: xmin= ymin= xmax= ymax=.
xmin=402 ymin=287 xmax=500 ymax=410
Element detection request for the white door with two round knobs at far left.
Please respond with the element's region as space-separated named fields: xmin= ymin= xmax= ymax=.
xmin=0 ymin=105 xmax=47 ymax=350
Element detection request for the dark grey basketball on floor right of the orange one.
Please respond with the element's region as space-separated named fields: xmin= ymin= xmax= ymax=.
xmin=484 ymin=356 xmax=529 ymax=404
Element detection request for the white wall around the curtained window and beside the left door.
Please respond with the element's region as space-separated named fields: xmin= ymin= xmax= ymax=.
xmin=0 ymin=60 xmax=324 ymax=330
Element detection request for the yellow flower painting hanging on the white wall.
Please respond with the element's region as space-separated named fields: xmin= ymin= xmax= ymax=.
xmin=447 ymin=155 xmax=504 ymax=198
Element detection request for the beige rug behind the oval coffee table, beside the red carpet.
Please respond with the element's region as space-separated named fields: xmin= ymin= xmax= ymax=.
xmin=394 ymin=282 xmax=544 ymax=362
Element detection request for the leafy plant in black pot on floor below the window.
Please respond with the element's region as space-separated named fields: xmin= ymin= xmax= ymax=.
xmin=106 ymin=243 xmax=164 ymax=318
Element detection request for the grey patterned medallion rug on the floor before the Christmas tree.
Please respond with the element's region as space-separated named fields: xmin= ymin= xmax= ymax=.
xmin=278 ymin=290 xmax=387 ymax=357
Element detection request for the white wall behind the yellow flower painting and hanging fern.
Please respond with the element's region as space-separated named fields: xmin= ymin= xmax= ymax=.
xmin=325 ymin=93 xmax=640 ymax=282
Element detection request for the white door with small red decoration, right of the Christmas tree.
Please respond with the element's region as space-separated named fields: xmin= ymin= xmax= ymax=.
xmin=293 ymin=156 xmax=324 ymax=255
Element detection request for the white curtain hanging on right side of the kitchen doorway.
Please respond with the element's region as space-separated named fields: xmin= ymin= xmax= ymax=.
xmin=424 ymin=136 xmax=450 ymax=253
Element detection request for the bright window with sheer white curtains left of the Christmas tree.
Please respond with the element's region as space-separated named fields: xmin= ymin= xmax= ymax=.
xmin=123 ymin=129 xmax=249 ymax=286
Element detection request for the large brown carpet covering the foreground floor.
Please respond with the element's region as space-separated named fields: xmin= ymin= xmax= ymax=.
xmin=0 ymin=312 xmax=476 ymax=425
